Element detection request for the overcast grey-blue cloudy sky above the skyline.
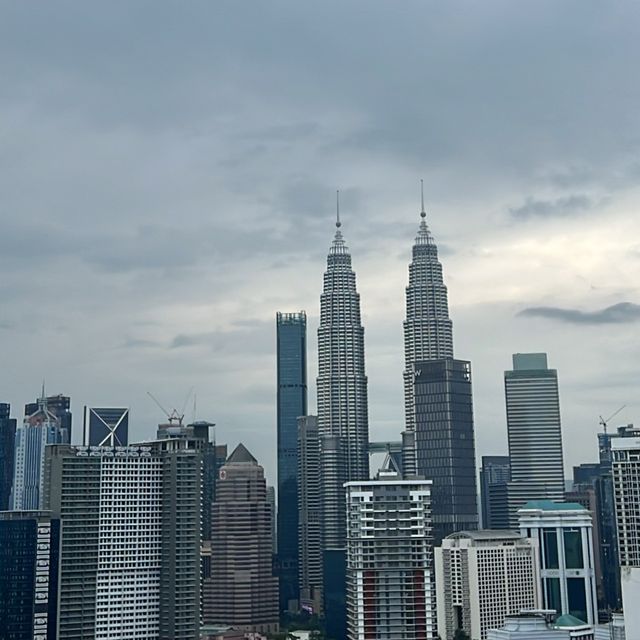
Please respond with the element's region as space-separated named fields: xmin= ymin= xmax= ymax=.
xmin=0 ymin=0 xmax=640 ymax=479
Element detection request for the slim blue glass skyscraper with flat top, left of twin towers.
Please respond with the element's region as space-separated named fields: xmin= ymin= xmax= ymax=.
xmin=276 ymin=311 xmax=307 ymax=611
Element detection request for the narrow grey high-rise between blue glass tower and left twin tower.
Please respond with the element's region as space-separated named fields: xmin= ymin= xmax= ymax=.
xmin=298 ymin=416 xmax=322 ymax=614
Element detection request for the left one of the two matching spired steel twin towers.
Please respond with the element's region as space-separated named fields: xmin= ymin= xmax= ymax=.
xmin=317 ymin=195 xmax=369 ymax=550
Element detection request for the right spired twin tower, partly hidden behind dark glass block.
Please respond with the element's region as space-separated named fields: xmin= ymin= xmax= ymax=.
xmin=404 ymin=181 xmax=453 ymax=431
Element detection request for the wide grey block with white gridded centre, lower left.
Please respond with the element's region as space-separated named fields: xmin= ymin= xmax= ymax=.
xmin=45 ymin=432 xmax=202 ymax=640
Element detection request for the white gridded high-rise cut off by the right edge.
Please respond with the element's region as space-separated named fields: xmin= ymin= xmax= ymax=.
xmin=611 ymin=428 xmax=640 ymax=640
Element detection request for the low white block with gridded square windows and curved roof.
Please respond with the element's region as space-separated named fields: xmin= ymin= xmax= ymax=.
xmin=434 ymin=529 xmax=541 ymax=640
